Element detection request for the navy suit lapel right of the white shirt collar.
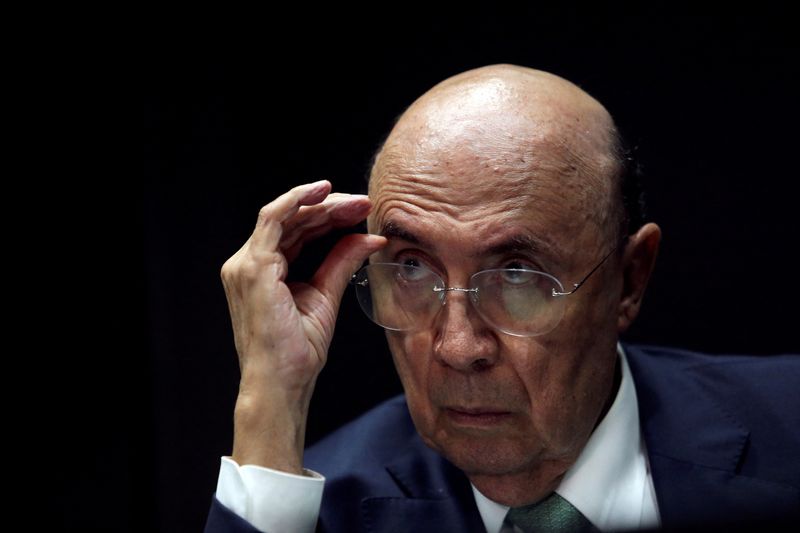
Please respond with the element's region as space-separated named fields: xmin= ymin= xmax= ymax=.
xmin=626 ymin=348 xmax=797 ymax=528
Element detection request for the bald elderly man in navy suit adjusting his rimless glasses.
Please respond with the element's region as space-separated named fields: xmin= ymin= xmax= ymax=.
xmin=207 ymin=65 xmax=800 ymax=533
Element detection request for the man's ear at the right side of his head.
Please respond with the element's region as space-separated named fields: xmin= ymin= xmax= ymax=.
xmin=617 ymin=223 xmax=661 ymax=333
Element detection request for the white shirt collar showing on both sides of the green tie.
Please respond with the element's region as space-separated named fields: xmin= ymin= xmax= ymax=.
xmin=472 ymin=344 xmax=647 ymax=533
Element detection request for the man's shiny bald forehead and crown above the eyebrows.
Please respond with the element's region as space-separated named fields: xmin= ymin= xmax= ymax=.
xmin=369 ymin=72 xmax=614 ymax=251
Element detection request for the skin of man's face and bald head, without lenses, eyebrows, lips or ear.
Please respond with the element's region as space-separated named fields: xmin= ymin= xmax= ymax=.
xmin=368 ymin=65 xmax=656 ymax=505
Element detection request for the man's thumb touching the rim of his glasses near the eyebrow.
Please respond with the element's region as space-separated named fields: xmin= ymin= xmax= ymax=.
xmin=311 ymin=234 xmax=388 ymax=308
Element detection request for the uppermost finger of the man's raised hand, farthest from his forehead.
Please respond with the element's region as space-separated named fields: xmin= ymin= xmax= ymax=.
xmin=253 ymin=180 xmax=331 ymax=249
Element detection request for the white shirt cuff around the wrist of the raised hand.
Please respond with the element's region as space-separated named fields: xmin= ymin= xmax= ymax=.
xmin=217 ymin=457 xmax=325 ymax=533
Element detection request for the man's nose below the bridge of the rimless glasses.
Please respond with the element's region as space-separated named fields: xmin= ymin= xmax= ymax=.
xmin=433 ymin=291 xmax=498 ymax=372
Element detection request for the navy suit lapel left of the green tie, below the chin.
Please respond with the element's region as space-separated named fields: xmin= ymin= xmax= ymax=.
xmin=361 ymin=439 xmax=485 ymax=533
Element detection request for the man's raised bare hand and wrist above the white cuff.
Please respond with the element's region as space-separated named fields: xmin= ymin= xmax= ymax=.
xmin=221 ymin=181 xmax=386 ymax=474
